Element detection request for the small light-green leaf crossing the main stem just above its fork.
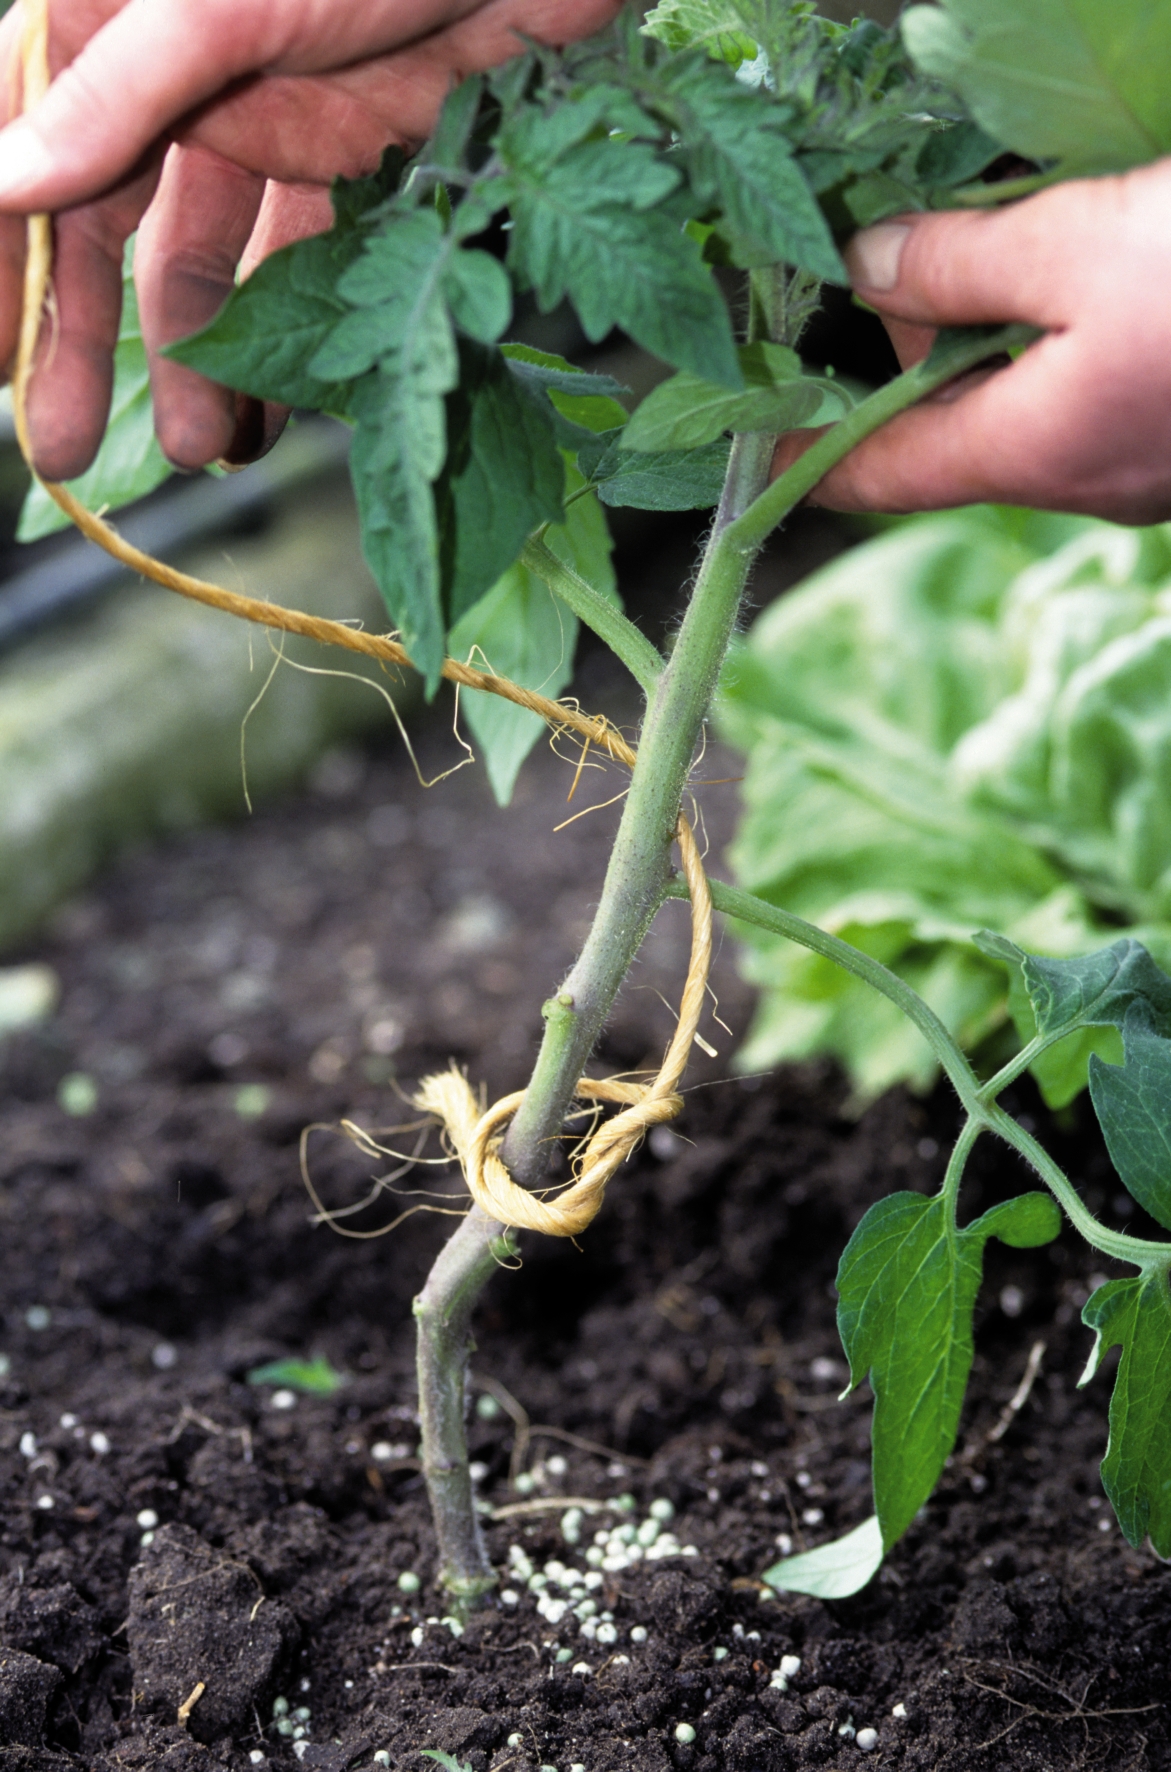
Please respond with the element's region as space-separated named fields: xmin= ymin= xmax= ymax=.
xmin=622 ymin=342 xmax=849 ymax=454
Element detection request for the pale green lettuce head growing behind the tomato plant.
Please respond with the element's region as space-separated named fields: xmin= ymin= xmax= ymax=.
xmin=721 ymin=510 xmax=1171 ymax=1108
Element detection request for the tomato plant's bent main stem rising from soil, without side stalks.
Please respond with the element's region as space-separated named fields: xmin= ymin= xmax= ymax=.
xmin=415 ymin=436 xmax=772 ymax=1605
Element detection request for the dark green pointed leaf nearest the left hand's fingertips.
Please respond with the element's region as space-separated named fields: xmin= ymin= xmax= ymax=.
xmin=165 ymin=229 xmax=361 ymax=411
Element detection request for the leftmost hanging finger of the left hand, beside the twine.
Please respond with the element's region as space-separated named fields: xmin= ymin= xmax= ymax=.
xmin=27 ymin=170 xmax=156 ymax=480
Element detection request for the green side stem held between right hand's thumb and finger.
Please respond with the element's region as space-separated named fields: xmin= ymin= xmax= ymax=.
xmin=728 ymin=326 xmax=1036 ymax=553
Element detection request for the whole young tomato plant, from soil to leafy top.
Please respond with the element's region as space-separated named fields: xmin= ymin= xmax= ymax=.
xmin=31 ymin=0 xmax=1171 ymax=1607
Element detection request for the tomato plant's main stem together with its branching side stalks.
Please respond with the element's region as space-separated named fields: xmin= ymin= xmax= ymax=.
xmin=415 ymin=308 xmax=1019 ymax=1605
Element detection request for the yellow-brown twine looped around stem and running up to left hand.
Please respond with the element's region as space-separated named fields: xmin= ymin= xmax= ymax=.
xmin=12 ymin=0 xmax=712 ymax=1237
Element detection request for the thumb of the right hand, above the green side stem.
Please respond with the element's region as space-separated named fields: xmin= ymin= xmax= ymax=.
xmin=845 ymin=179 xmax=1118 ymax=328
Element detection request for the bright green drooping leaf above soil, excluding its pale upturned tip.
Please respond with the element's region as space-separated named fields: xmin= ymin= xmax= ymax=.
xmin=838 ymin=1193 xmax=1061 ymax=1551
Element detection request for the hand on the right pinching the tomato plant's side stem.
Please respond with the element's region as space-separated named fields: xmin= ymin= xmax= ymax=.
xmin=774 ymin=159 xmax=1171 ymax=523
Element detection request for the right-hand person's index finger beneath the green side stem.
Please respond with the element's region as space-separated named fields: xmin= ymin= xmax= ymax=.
xmin=772 ymin=335 xmax=1171 ymax=523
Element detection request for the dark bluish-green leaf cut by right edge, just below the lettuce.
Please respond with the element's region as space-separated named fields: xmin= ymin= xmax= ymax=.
xmin=1090 ymin=1013 xmax=1171 ymax=1230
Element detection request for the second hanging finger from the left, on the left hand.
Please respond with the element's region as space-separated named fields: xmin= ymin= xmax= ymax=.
xmin=135 ymin=145 xmax=264 ymax=470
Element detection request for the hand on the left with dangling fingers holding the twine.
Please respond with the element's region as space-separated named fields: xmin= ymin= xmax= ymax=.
xmin=0 ymin=0 xmax=618 ymax=480
